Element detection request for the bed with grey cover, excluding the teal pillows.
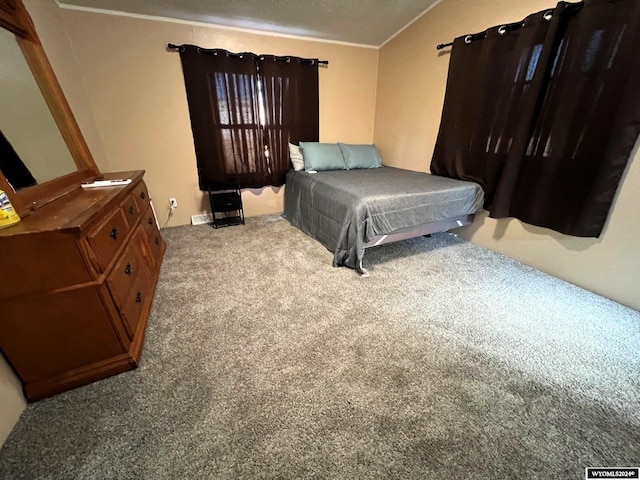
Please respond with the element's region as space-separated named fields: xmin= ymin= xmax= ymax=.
xmin=284 ymin=167 xmax=484 ymax=276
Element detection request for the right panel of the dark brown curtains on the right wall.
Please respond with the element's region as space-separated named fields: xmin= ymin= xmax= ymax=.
xmin=494 ymin=0 xmax=640 ymax=237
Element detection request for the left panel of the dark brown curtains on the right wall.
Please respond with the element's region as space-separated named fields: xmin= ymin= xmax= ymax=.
xmin=431 ymin=12 xmax=550 ymax=207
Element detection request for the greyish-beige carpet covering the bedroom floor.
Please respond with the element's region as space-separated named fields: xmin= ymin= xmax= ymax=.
xmin=0 ymin=216 xmax=640 ymax=480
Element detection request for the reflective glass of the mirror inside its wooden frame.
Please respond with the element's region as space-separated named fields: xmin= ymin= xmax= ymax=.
xmin=0 ymin=29 xmax=77 ymax=191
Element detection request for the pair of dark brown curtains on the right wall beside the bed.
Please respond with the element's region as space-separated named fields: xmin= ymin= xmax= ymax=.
xmin=431 ymin=0 xmax=640 ymax=237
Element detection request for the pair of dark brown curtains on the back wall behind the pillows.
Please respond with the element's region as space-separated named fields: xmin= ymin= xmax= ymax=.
xmin=180 ymin=45 xmax=318 ymax=190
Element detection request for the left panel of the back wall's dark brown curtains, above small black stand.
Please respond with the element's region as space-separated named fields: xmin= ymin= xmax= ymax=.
xmin=180 ymin=45 xmax=269 ymax=190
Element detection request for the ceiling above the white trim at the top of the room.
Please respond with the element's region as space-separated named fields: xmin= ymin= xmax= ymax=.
xmin=57 ymin=0 xmax=439 ymax=46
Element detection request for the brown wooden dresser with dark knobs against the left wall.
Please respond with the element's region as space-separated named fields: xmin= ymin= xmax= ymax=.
xmin=0 ymin=171 xmax=165 ymax=400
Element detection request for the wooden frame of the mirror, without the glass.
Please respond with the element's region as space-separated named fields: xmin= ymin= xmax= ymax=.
xmin=0 ymin=0 xmax=100 ymax=217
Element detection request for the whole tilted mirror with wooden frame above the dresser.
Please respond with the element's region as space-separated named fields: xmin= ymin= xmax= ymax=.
xmin=0 ymin=0 xmax=99 ymax=216
